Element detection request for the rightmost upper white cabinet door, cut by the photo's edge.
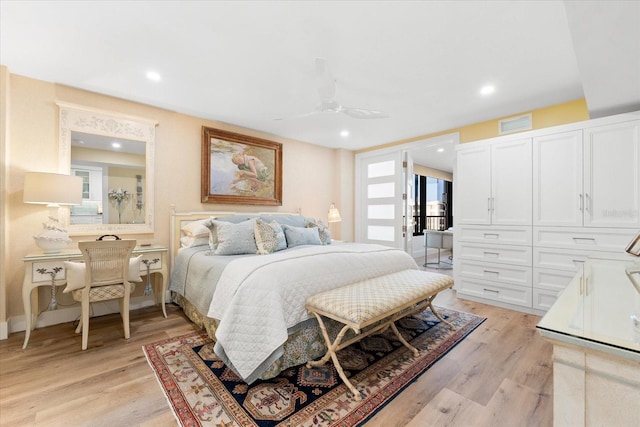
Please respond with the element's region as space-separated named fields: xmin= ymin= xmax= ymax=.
xmin=584 ymin=120 xmax=640 ymax=227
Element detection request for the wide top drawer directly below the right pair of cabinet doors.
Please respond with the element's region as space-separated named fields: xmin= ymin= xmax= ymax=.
xmin=533 ymin=227 xmax=638 ymax=252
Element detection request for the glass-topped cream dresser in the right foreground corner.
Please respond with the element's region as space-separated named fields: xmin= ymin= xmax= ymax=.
xmin=537 ymin=254 xmax=640 ymax=426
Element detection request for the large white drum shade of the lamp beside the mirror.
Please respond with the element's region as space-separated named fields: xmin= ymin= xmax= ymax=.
xmin=23 ymin=172 xmax=82 ymax=205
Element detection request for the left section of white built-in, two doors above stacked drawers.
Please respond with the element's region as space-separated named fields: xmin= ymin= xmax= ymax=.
xmin=454 ymin=137 xmax=532 ymax=309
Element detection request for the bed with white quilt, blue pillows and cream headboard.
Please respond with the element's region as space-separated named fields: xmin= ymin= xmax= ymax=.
xmin=169 ymin=212 xmax=418 ymax=384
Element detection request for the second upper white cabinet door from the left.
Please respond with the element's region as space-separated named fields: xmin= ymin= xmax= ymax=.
xmin=491 ymin=139 xmax=532 ymax=225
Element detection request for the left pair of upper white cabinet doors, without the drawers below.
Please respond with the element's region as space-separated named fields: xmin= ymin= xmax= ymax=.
xmin=455 ymin=139 xmax=532 ymax=225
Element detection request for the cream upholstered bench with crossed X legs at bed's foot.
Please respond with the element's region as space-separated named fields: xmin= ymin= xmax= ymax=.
xmin=305 ymin=270 xmax=454 ymax=400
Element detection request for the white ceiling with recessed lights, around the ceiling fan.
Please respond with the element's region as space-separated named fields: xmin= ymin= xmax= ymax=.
xmin=0 ymin=0 xmax=640 ymax=174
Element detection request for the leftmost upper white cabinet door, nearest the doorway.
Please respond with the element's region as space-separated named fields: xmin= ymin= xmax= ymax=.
xmin=454 ymin=146 xmax=491 ymax=224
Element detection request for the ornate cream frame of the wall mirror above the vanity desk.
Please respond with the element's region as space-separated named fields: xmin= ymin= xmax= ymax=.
xmin=57 ymin=102 xmax=158 ymax=236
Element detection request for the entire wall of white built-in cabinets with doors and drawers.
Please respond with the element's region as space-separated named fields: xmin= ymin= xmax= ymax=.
xmin=454 ymin=112 xmax=640 ymax=314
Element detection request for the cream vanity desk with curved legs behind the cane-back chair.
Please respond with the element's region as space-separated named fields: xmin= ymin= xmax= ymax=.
xmin=22 ymin=245 xmax=168 ymax=348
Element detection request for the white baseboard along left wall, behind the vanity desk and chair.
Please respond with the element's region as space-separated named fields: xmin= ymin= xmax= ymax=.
xmin=7 ymin=296 xmax=165 ymax=339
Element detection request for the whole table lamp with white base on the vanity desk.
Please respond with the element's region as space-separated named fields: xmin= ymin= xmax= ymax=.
xmin=23 ymin=172 xmax=82 ymax=253
